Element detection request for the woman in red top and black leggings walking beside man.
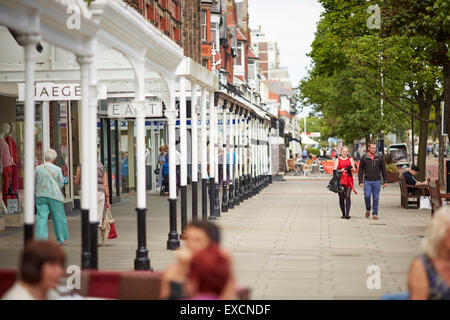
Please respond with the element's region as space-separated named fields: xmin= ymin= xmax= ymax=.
xmin=334 ymin=146 xmax=356 ymax=219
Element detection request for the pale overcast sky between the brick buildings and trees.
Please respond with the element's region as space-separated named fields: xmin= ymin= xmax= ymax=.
xmin=248 ymin=0 xmax=322 ymax=88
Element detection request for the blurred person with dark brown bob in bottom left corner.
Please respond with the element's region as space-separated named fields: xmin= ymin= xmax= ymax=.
xmin=2 ymin=241 xmax=66 ymax=300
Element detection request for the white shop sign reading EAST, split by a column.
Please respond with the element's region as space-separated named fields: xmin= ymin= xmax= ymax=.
xmin=108 ymin=99 xmax=163 ymax=118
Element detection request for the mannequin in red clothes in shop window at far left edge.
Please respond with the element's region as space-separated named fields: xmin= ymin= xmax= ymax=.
xmin=0 ymin=123 xmax=17 ymax=203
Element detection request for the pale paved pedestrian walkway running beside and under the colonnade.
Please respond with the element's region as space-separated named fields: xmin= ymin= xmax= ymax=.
xmin=0 ymin=177 xmax=430 ymax=299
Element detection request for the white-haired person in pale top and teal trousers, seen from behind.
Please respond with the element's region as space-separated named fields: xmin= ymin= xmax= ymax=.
xmin=35 ymin=149 xmax=69 ymax=244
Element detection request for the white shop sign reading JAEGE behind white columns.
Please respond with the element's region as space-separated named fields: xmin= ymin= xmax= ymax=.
xmin=18 ymin=82 xmax=106 ymax=101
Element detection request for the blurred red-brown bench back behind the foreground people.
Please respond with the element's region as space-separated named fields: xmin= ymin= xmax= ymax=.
xmin=0 ymin=269 xmax=251 ymax=300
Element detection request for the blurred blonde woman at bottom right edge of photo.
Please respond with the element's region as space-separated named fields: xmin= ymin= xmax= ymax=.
xmin=408 ymin=206 xmax=450 ymax=300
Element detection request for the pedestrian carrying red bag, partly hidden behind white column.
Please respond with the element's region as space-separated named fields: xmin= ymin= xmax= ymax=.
xmin=73 ymin=150 xmax=111 ymax=229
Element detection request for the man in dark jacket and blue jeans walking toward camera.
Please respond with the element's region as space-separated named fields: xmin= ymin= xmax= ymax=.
xmin=358 ymin=142 xmax=387 ymax=220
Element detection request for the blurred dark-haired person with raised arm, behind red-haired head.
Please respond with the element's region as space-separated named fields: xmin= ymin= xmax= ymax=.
xmin=160 ymin=221 xmax=236 ymax=300
